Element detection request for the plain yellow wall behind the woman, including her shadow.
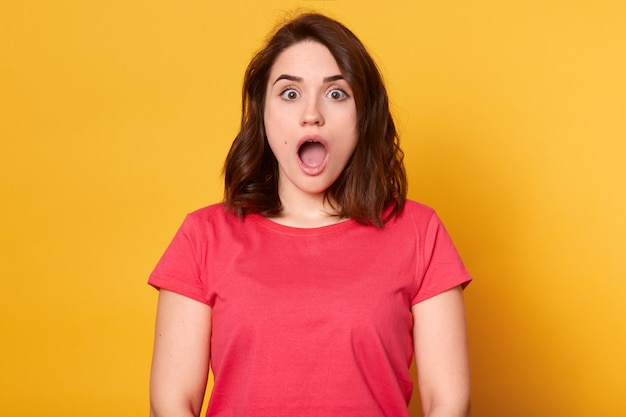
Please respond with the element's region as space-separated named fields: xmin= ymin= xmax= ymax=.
xmin=0 ymin=0 xmax=626 ymax=417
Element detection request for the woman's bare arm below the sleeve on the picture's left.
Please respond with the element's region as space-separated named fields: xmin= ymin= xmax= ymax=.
xmin=150 ymin=290 xmax=211 ymax=417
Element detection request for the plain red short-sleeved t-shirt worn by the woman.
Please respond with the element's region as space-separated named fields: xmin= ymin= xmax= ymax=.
xmin=149 ymin=201 xmax=471 ymax=417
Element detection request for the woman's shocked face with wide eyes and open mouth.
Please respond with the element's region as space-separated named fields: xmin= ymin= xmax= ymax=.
xmin=264 ymin=41 xmax=358 ymax=200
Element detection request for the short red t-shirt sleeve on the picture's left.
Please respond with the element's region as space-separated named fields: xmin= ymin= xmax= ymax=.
xmin=148 ymin=215 xmax=208 ymax=304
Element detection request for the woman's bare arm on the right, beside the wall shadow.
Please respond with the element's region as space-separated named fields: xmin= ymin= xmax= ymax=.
xmin=411 ymin=286 xmax=470 ymax=417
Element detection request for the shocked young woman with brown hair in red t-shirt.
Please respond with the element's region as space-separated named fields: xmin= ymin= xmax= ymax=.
xmin=150 ymin=14 xmax=470 ymax=417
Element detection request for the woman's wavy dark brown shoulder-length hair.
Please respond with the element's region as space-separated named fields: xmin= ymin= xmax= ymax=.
xmin=224 ymin=13 xmax=407 ymax=227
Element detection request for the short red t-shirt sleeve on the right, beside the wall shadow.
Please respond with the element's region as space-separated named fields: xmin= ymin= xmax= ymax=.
xmin=411 ymin=212 xmax=472 ymax=305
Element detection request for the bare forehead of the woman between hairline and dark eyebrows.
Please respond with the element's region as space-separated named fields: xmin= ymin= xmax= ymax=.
xmin=270 ymin=40 xmax=341 ymax=78
